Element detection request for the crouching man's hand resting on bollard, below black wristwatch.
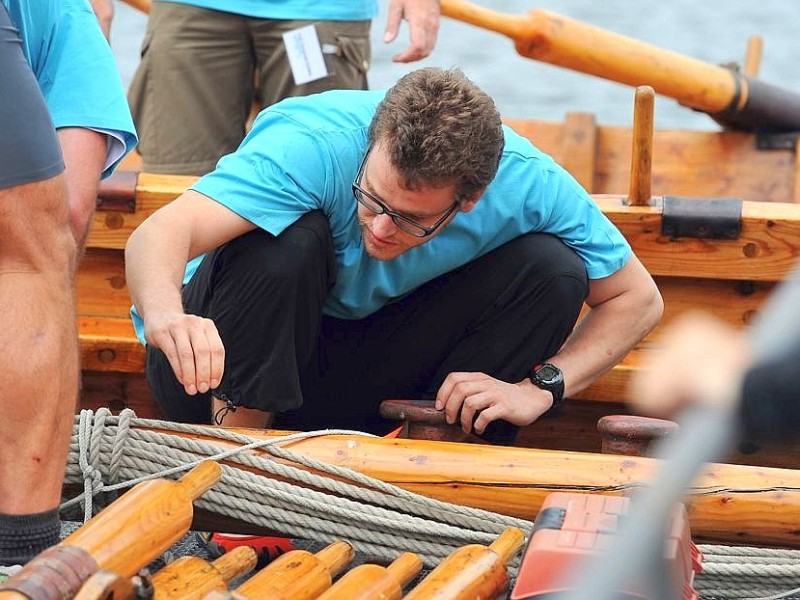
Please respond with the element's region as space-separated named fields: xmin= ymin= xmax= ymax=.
xmin=436 ymin=373 xmax=553 ymax=435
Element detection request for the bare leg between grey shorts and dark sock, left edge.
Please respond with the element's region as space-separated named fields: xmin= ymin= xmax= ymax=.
xmin=0 ymin=175 xmax=78 ymax=515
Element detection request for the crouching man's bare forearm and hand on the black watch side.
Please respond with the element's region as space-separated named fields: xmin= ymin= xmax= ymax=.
xmin=436 ymin=256 xmax=664 ymax=434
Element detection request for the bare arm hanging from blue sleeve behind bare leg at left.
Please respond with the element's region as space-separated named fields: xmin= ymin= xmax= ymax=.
xmin=58 ymin=127 xmax=107 ymax=254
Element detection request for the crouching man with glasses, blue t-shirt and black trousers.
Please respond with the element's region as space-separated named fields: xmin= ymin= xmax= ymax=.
xmin=126 ymin=69 xmax=663 ymax=442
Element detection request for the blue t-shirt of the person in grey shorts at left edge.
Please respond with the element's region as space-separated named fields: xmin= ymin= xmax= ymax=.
xmin=2 ymin=0 xmax=137 ymax=177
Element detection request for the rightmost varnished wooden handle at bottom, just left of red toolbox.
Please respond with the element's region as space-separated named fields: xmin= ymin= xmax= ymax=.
xmin=405 ymin=527 xmax=525 ymax=600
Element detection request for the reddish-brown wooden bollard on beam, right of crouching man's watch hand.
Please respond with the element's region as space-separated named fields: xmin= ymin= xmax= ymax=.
xmin=597 ymin=415 xmax=678 ymax=456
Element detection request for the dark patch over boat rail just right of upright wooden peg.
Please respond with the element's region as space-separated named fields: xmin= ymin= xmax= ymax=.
xmin=661 ymin=196 xmax=742 ymax=240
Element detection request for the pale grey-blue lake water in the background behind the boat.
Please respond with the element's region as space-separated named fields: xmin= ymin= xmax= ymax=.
xmin=112 ymin=0 xmax=800 ymax=129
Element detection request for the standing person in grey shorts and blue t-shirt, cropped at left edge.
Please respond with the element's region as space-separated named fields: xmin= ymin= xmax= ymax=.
xmin=0 ymin=0 xmax=136 ymax=570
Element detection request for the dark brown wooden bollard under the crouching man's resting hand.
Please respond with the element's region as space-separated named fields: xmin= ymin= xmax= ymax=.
xmin=379 ymin=399 xmax=485 ymax=443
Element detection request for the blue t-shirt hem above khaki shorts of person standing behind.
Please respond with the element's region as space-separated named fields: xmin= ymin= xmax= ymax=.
xmin=162 ymin=0 xmax=378 ymax=21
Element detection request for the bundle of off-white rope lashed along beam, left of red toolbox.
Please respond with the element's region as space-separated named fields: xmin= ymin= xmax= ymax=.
xmin=62 ymin=409 xmax=532 ymax=569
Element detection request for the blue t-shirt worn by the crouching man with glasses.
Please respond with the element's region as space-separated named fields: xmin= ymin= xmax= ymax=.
xmin=134 ymin=91 xmax=631 ymax=339
